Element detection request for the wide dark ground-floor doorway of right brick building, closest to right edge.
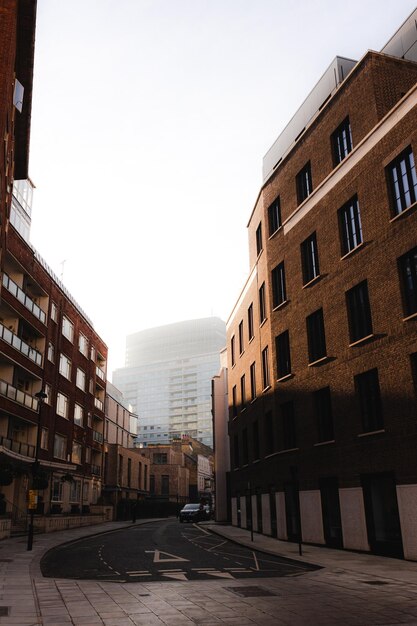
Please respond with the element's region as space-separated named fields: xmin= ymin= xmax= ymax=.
xmin=362 ymin=474 xmax=404 ymax=558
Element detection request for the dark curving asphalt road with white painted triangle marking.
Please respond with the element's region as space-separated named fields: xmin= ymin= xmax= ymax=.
xmin=41 ymin=519 xmax=319 ymax=582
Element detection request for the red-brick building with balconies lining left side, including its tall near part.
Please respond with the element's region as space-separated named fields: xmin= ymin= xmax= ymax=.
xmin=0 ymin=0 xmax=107 ymax=519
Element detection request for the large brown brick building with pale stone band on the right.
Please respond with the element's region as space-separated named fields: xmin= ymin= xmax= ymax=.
xmin=227 ymin=12 xmax=417 ymax=559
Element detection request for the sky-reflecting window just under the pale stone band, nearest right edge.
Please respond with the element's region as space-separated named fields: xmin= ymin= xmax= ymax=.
xmin=386 ymin=146 xmax=417 ymax=215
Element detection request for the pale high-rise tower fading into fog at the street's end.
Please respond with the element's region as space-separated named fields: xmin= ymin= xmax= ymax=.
xmin=113 ymin=317 xmax=226 ymax=446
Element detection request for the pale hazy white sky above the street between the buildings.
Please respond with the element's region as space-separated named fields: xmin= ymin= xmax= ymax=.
xmin=30 ymin=0 xmax=415 ymax=380
